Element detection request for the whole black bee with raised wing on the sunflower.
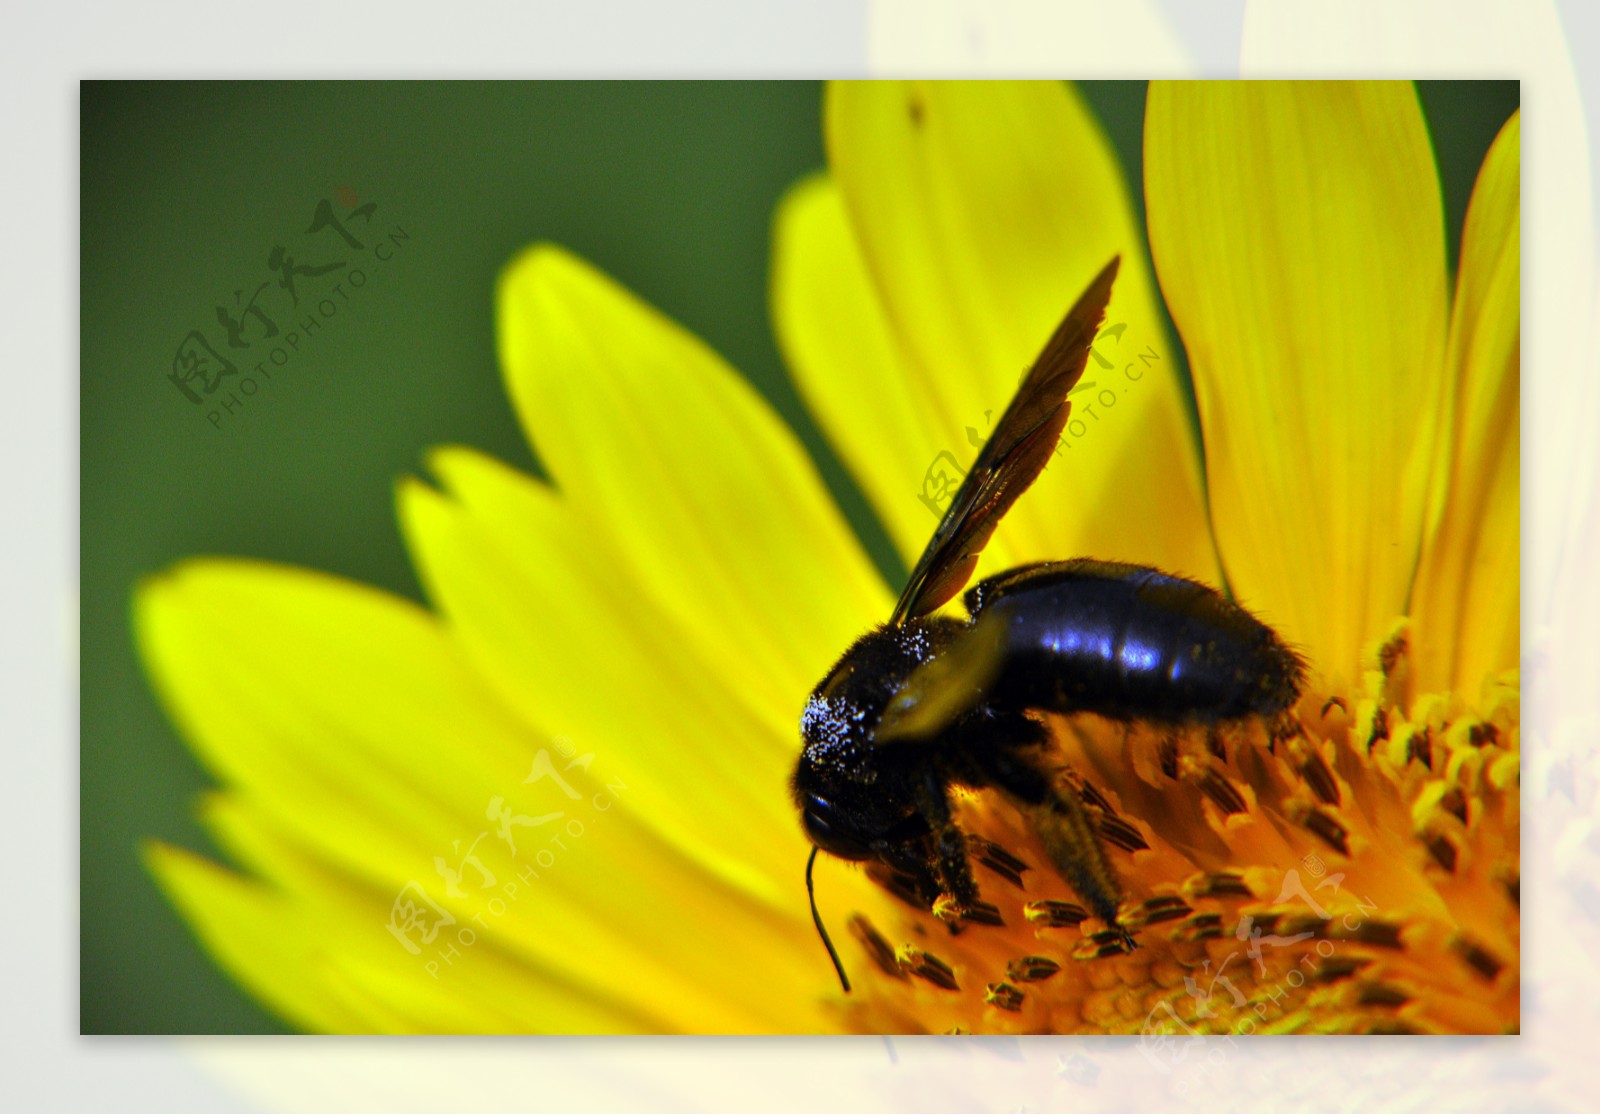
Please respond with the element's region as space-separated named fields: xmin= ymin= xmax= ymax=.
xmin=790 ymin=258 xmax=1304 ymax=992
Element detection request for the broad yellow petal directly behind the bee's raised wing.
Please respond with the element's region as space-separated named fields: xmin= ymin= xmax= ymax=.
xmin=825 ymin=82 xmax=1216 ymax=581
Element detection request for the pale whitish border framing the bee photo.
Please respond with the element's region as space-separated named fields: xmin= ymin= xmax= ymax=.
xmin=0 ymin=0 xmax=1600 ymax=1110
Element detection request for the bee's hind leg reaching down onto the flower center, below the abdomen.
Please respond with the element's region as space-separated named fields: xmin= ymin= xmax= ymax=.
xmin=976 ymin=729 xmax=1131 ymax=944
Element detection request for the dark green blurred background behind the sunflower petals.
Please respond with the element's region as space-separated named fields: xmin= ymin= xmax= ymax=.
xmin=80 ymin=82 xmax=1518 ymax=1033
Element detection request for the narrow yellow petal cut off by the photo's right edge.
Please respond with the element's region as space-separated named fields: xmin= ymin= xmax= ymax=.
xmin=1414 ymin=112 xmax=1522 ymax=696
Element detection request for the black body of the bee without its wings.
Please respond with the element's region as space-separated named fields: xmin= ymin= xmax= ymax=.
xmin=794 ymin=558 xmax=1304 ymax=897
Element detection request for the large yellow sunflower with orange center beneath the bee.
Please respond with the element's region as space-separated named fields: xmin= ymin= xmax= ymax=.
xmin=136 ymin=83 xmax=1520 ymax=1036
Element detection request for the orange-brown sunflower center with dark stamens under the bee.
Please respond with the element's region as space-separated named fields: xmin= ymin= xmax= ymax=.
xmin=840 ymin=627 xmax=1520 ymax=1036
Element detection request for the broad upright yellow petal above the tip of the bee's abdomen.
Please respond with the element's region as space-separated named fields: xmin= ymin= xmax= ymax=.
xmin=1144 ymin=82 xmax=1446 ymax=685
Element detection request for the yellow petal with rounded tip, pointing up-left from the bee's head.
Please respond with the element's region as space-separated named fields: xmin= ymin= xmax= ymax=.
xmin=498 ymin=245 xmax=886 ymax=691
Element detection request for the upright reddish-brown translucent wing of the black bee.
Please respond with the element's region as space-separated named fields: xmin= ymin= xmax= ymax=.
xmin=890 ymin=256 xmax=1122 ymax=625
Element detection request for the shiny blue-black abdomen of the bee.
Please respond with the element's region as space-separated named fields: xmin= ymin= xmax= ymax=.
xmin=966 ymin=560 xmax=1304 ymax=725
